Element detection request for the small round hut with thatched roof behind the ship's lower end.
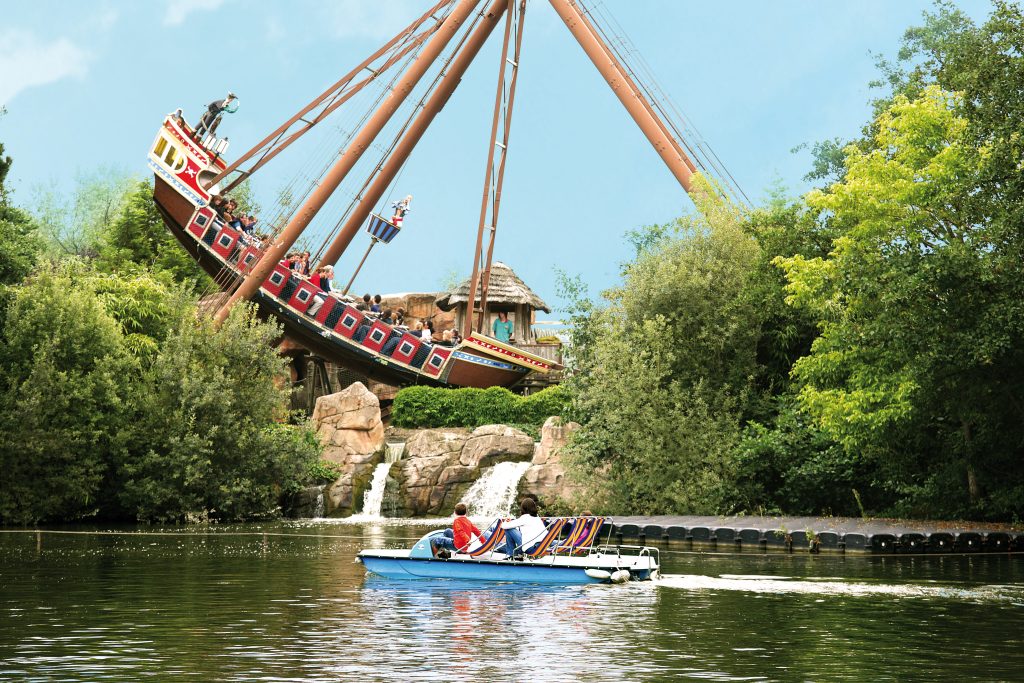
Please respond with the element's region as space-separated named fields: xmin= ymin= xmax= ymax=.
xmin=437 ymin=261 xmax=551 ymax=343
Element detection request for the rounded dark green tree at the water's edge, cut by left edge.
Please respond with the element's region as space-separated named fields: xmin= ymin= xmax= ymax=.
xmin=0 ymin=266 xmax=133 ymax=523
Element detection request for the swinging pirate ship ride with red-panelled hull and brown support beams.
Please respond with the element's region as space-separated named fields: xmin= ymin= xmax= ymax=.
xmin=148 ymin=0 xmax=745 ymax=387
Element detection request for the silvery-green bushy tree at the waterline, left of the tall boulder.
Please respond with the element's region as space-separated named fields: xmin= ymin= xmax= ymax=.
xmin=117 ymin=306 xmax=318 ymax=521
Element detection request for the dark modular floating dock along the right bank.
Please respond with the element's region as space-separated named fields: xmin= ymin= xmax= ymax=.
xmin=611 ymin=516 xmax=1024 ymax=555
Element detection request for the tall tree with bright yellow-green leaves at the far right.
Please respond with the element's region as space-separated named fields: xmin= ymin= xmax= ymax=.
xmin=781 ymin=85 xmax=1024 ymax=515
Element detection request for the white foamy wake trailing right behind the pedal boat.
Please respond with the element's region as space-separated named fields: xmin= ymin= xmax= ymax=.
xmin=657 ymin=574 xmax=1024 ymax=606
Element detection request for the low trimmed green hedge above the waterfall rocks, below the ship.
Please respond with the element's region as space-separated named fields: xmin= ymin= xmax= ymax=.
xmin=393 ymin=386 xmax=569 ymax=427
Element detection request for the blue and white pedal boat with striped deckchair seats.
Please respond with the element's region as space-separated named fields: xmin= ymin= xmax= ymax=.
xmin=356 ymin=518 xmax=660 ymax=585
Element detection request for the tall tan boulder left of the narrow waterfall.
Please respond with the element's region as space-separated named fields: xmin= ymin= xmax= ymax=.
xmin=313 ymin=382 xmax=384 ymax=515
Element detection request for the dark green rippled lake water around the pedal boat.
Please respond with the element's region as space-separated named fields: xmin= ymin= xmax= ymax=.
xmin=0 ymin=522 xmax=1024 ymax=681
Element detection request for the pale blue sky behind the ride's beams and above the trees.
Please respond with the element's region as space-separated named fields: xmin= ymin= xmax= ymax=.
xmin=0 ymin=0 xmax=989 ymax=314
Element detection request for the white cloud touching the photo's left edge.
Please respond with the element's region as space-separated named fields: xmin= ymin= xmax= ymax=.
xmin=0 ymin=29 xmax=92 ymax=104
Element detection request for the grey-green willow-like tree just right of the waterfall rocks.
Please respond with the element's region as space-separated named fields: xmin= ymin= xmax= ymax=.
xmin=569 ymin=184 xmax=759 ymax=513
